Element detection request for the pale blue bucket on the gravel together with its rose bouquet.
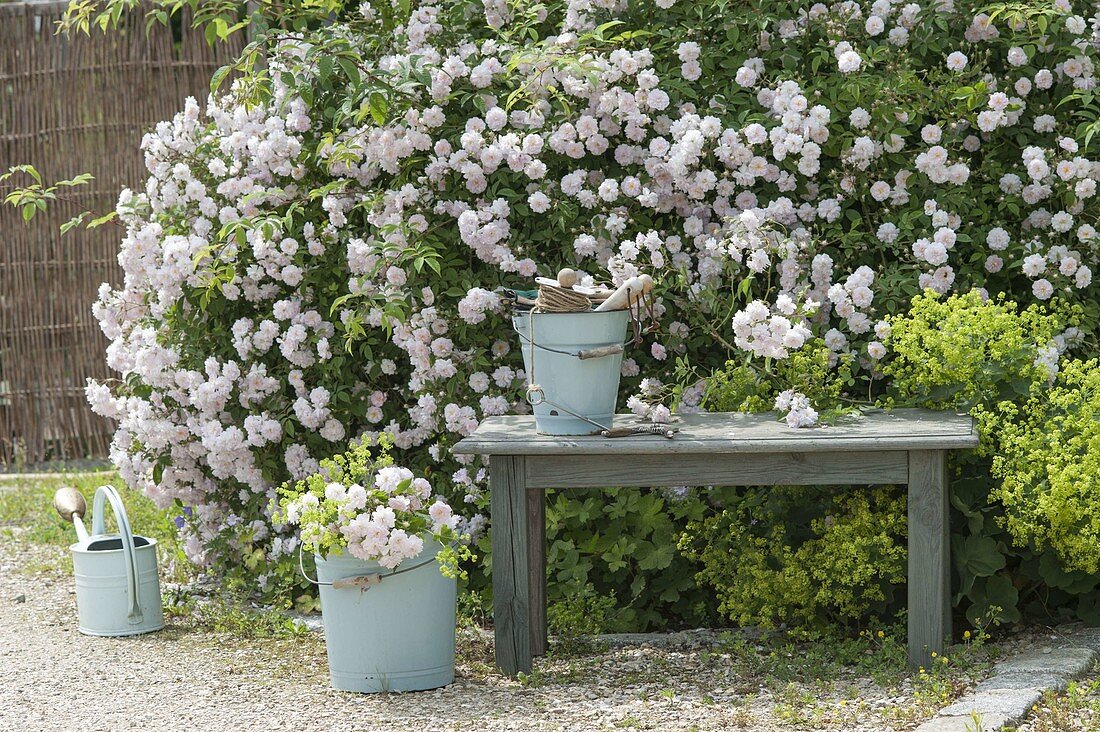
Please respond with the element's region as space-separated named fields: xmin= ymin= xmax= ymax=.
xmin=276 ymin=437 xmax=471 ymax=692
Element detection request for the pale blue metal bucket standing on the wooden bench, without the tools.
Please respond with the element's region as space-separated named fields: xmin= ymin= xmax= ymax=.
xmin=512 ymin=310 xmax=630 ymax=435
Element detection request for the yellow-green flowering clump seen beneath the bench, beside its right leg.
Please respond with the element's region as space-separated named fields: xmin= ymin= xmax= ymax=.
xmin=680 ymin=488 xmax=905 ymax=627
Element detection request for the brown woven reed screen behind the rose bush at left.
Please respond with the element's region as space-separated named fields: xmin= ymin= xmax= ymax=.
xmin=0 ymin=0 xmax=240 ymax=465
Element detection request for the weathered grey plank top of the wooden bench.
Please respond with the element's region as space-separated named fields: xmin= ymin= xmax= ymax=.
xmin=453 ymin=409 xmax=978 ymax=455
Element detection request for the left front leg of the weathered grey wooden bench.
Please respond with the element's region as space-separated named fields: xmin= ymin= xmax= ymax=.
xmin=490 ymin=456 xmax=531 ymax=676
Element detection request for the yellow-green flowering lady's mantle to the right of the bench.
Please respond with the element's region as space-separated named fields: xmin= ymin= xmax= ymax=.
xmin=883 ymin=293 xmax=1100 ymax=625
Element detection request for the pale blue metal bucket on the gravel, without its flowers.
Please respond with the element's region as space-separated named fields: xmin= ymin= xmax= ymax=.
xmin=316 ymin=540 xmax=457 ymax=693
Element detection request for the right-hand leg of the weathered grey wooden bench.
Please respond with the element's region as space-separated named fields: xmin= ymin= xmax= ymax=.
xmin=909 ymin=450 xmax=952 ymax=668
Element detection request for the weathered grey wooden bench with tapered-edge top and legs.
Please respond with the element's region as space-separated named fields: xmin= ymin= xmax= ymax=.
xmin=454 ymin=409 xmax=978 ymax=675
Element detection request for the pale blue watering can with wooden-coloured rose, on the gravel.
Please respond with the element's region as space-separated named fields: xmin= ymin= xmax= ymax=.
xmin=54 ymin=485 xmax=164 ymax=636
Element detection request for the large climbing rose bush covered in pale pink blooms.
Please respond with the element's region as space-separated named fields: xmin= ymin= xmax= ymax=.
xmin=88 ymin=0 xmax=1100 ymax=589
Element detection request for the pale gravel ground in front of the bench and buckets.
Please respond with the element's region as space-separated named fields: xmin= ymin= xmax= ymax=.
xmin=0 ymin=534 xmax=1038 ymax=732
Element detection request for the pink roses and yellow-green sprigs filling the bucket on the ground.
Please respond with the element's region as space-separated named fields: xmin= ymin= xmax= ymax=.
xmin=276 ymin=440 xmax=471 ymax=577
